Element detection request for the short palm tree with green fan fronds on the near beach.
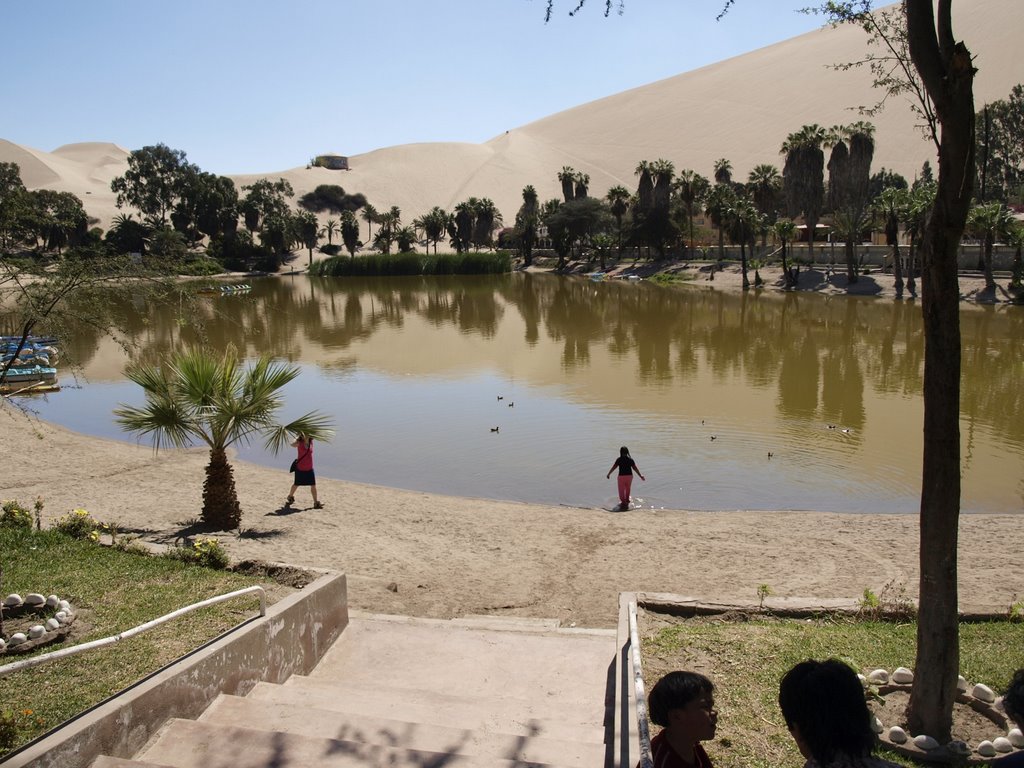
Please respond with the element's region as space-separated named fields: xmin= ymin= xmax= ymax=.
xmin=114 ymin=346 xmax=333 ymax=530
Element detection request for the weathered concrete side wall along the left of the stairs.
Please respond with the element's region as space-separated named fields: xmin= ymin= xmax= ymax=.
xmin=0 ymin=573 xmax=348 ymax=768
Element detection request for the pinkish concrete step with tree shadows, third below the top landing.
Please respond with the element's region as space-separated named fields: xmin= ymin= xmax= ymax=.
xmin=142 ymin=720 xmax=593 ymax=768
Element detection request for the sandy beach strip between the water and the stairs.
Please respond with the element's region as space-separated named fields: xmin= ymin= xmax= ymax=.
xmin=0 ymin=350 xmax=1024 ymax=627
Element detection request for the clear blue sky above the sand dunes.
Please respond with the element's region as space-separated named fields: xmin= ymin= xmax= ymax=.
xmin=0 ymin=0 xmax=821 ymax=174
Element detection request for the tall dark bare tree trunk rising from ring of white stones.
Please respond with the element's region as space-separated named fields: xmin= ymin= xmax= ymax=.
xmin=904 ymin=0 xmax=975 ymax=743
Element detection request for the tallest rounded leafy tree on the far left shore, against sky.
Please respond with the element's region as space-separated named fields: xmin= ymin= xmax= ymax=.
xmin=111 ymin=143 xmax=199 ymax=226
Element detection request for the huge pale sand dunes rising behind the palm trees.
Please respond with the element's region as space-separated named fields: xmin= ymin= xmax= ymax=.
xmin=0 ymin=0 xmax=1024 ymax=234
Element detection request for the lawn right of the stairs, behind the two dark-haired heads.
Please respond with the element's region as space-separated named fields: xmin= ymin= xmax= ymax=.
xmin=640 ymin=611 xmax=1024 ymax=768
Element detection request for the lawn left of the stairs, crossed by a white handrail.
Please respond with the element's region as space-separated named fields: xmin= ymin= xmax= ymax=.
xmin=0 ymin=527 xmax=290 ymax=758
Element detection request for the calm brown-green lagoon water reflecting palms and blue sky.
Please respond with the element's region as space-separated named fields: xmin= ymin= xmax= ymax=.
xmin=33 ymin=273 xmax=1024 ymax=514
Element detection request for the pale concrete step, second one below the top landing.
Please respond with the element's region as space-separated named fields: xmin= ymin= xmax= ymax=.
xmin=200 ymin=695 xmax=605 ymax=768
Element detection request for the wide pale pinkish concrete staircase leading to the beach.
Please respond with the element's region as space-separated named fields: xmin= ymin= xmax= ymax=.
xmin=92 ymin=615 xmax=616 ymax=768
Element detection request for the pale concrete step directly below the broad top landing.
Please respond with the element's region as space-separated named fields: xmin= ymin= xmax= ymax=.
xmin=249 ymin=675 xmax=604 ymax=741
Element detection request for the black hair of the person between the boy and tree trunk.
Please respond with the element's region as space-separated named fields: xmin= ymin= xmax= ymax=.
xmin=778 ymin=658 xmax=874 ymax=766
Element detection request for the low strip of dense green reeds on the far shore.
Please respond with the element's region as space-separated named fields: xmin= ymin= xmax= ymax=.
xmin=309 ymin=251 xmax=512 ymax=278
